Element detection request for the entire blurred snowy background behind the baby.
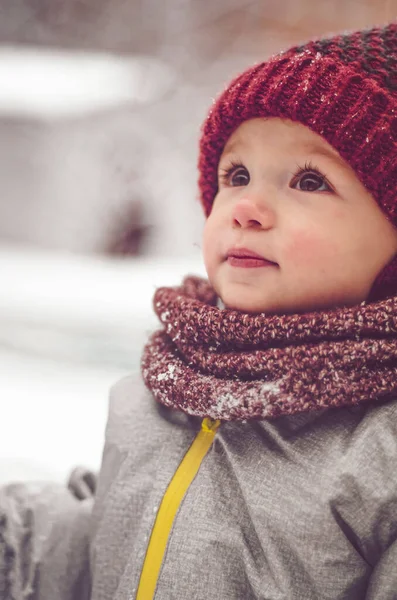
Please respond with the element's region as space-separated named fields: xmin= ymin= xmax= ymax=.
xmin=0 ymin=0 xmax=397 ymax=482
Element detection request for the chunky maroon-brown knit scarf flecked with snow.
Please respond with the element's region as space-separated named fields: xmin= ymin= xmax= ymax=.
xmin=142 ymin=276 xmax=397 ymax=421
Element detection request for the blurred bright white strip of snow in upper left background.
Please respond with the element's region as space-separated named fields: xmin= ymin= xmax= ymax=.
xmin=0 ymin=46 xmax=175 ymax=120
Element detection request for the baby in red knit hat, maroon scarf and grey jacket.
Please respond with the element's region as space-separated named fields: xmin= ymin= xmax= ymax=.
xmin=91 ymin=24 xmax=397 ymax=600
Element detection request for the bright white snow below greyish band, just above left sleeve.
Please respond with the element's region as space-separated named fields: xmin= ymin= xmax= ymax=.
xmin=0 ymin=351 xmax=121 ymax=482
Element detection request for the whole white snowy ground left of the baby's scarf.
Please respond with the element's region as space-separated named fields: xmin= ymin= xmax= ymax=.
xmin=0 ymin=246 xmax=204 ymax=483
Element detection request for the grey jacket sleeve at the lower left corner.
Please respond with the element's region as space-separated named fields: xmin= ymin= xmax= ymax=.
xmin=0 ymin=483 xmax=93 ymax=600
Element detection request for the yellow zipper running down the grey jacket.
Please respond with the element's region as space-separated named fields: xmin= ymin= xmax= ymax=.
xmin=136 ymin=419 xmax=220 ymax=600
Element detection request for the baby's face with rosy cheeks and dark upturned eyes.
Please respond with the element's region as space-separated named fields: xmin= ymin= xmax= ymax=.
xmin=203 ymin=118 xmax=397 ymax=314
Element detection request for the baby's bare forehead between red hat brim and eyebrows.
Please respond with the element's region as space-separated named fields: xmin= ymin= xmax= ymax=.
xmin=222 ymin=117 xmax=347 ymax=166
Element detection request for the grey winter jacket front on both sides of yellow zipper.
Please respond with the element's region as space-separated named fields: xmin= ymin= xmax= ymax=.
xmin=91 ymin=376 xmax=397 ymax=600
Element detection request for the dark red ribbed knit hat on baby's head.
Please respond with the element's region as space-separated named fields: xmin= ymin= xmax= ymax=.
xmin=199 ymin=23 xmax=397 ymax=300
